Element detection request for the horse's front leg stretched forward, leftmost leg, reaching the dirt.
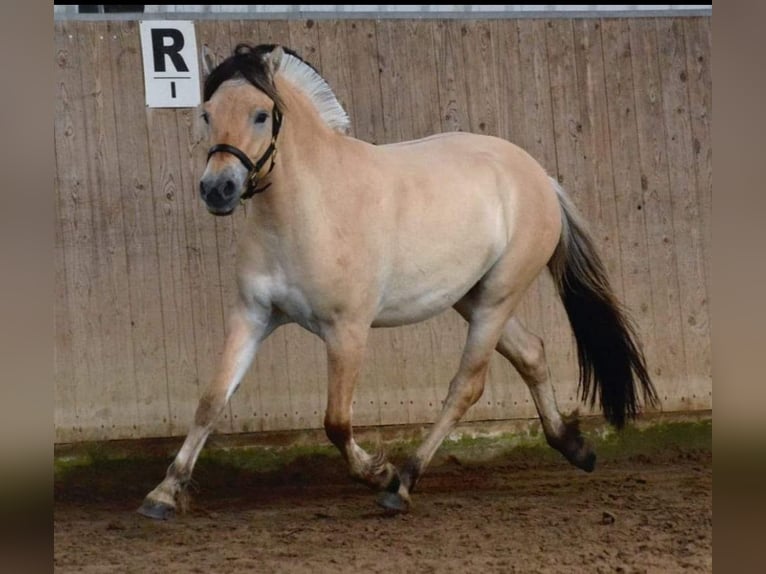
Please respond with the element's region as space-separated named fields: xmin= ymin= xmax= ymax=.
xmin=138 ymin=306 xmax=277 ymax=519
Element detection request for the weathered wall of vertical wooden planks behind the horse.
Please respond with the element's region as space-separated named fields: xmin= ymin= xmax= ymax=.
xmin=54 ymin=17 xmax=713 ymax=442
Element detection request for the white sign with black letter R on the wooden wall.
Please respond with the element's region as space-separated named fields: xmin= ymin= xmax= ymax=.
xmin=141 ymin=20 xmax=200 ymax=108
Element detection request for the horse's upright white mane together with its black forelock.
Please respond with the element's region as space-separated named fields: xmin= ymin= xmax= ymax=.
xmin=203 ymin=44 xmax=351 ymax=133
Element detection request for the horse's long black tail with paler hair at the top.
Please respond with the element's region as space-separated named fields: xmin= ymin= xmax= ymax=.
xmin=548 ymin=178 xmax=659 ymax=428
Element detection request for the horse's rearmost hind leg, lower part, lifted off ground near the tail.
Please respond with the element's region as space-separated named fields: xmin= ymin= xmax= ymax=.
xmin=496 ymin=318 xmax=596 ymax=472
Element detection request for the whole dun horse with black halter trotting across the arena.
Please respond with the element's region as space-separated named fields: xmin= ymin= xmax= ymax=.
xmin=139 ymin=44 xmax=658 ymax=519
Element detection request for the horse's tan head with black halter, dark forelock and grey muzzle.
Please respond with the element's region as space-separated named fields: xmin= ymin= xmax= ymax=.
xmin=200 ymin=44 xmax=284 ymax=215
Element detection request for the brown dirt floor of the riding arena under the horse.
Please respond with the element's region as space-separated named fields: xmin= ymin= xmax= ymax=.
xmin=54 ymin=425 xmax=713 ymax=574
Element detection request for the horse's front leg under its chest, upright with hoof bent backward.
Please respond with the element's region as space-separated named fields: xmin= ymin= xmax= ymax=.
xmin=324 ymin=325 xmax=399 ymax=490
